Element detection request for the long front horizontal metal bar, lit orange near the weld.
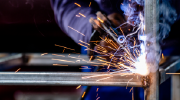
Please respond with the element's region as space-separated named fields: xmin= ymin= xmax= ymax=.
xmin=0 ymin=72 xmax=142 ymax=87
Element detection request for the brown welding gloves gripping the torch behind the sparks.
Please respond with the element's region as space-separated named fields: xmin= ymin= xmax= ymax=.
xmin=88 ymin=12 xmax=125 ymax=60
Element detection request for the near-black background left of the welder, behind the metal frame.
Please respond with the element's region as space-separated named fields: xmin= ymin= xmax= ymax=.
xmin=0 ymin=0 xmax=80 ymax=100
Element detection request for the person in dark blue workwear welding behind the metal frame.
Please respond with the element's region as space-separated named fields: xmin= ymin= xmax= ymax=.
xmin=51 ymin=0 xmax=180 ymax=100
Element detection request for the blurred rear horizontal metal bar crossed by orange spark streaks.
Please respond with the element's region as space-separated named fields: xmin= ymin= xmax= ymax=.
xmin=26 ymin=53 xmax=104 ymax=66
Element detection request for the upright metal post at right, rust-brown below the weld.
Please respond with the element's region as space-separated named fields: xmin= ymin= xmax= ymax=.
xmin=144 ymin=0 xmax=159 ymax=100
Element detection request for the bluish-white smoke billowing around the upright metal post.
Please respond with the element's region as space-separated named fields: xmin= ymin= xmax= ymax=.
xmin=120 ymin=0 xmax=177 ymax=72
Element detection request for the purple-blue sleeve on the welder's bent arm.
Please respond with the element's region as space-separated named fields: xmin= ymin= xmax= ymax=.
xmin=50 ymin=0 xmax=99 ymax=43
